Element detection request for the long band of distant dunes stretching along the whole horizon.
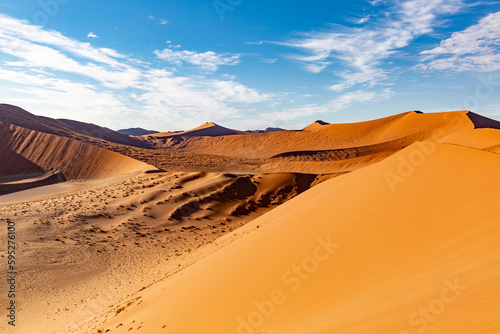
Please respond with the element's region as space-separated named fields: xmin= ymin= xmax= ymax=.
xmin=0 ymin=105 xmax=500 ymax=174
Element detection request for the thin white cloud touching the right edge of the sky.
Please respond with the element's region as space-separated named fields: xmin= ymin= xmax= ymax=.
xmin=419 ymin=12 xmax=500 ymax=72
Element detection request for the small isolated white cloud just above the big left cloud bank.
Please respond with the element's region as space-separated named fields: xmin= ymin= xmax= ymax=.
xmin=155 ymin=49 xmax=240 ymax=71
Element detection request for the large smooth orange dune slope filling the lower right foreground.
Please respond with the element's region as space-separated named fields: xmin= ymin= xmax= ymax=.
xmin=101 ymin=142 xmax=500 ymax=334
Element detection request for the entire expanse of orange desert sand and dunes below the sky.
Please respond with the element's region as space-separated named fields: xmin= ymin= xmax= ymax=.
xmin=0 ymin=105 xmax=500 ymax=334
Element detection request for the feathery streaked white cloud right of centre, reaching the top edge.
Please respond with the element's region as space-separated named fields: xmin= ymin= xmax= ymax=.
xmin=278 ymin=0 xmax=463 ymax=91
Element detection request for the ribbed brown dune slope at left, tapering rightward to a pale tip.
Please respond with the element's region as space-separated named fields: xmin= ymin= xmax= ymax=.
xmin=0 ymin=122 xmax=156 ymax=180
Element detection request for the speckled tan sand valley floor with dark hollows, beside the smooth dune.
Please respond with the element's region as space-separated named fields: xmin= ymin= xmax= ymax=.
xmin=0 ymin=172 xmax=322 ymax=334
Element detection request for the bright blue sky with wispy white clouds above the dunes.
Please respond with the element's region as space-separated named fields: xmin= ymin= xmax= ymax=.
xmin=0 ymin=0 xmax=500 ymax=131
